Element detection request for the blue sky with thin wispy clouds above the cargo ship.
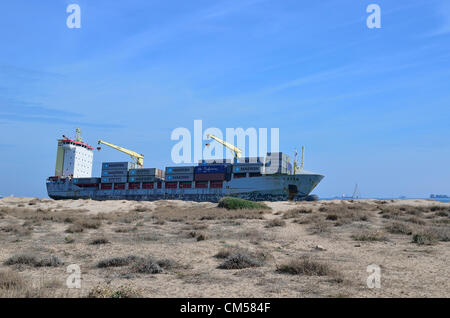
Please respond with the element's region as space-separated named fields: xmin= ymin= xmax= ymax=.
xmin=0 ymin=0 xmax=450 ymax=197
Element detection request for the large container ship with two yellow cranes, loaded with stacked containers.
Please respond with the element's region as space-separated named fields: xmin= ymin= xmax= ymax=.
xmin=46 ymin=129 xmax=324 ymax=202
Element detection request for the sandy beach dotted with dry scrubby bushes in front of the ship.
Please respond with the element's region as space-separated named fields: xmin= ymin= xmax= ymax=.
xmin=0 ymin=197 xmax=450 ymax=297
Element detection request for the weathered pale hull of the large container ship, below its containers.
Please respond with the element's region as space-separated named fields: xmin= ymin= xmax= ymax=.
xmin=47 ymin=173 xmax=324 ymax=202
